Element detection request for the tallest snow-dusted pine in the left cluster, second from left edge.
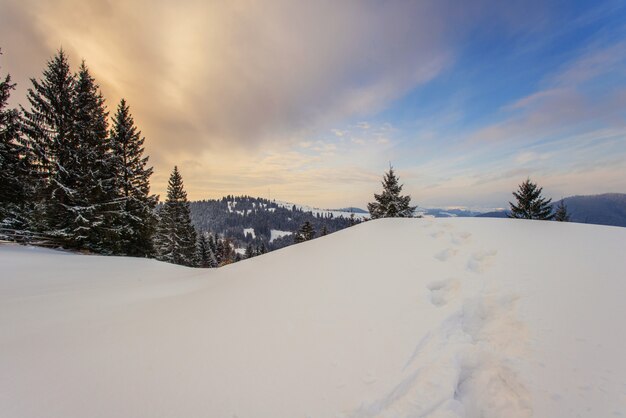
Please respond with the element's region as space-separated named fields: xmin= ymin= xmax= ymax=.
xmin=22 ymin=50 xmax=79 ymax=246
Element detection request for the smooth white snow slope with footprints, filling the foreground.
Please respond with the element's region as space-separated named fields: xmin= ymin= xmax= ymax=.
xmin=0 ymin=218 xmax=626 ymax=418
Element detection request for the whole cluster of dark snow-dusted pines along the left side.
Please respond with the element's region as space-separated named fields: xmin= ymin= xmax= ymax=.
xmin=0 ymin=50 xmax=241 ymax=267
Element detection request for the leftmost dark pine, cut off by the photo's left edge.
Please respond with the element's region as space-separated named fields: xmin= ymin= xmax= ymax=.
xmin=0 ymin=52 xmax=30 ymax=230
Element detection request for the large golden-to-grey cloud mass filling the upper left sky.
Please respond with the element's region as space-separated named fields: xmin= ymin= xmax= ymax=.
xmin=2 ymin=0 xmax=458 ymax=149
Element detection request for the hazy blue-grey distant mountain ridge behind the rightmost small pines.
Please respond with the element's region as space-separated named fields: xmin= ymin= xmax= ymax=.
xmin=476 ymin=193 xmax=626 ymax=227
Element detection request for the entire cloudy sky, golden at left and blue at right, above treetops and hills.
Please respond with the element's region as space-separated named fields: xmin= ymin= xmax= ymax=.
xmin=0 ymin=0 xmax=626 ymax=209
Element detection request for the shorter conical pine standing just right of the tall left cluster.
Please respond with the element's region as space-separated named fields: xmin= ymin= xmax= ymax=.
xmin=156 ymin=167 xmax=196 ymax=267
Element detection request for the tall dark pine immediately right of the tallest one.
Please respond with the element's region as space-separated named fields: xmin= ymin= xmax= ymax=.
xmin=70 ymin=62 xmax=121 ymax=254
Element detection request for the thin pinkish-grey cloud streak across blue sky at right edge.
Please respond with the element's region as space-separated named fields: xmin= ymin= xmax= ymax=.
xmin=467 ymin=36 xmax=626 ymax=146
